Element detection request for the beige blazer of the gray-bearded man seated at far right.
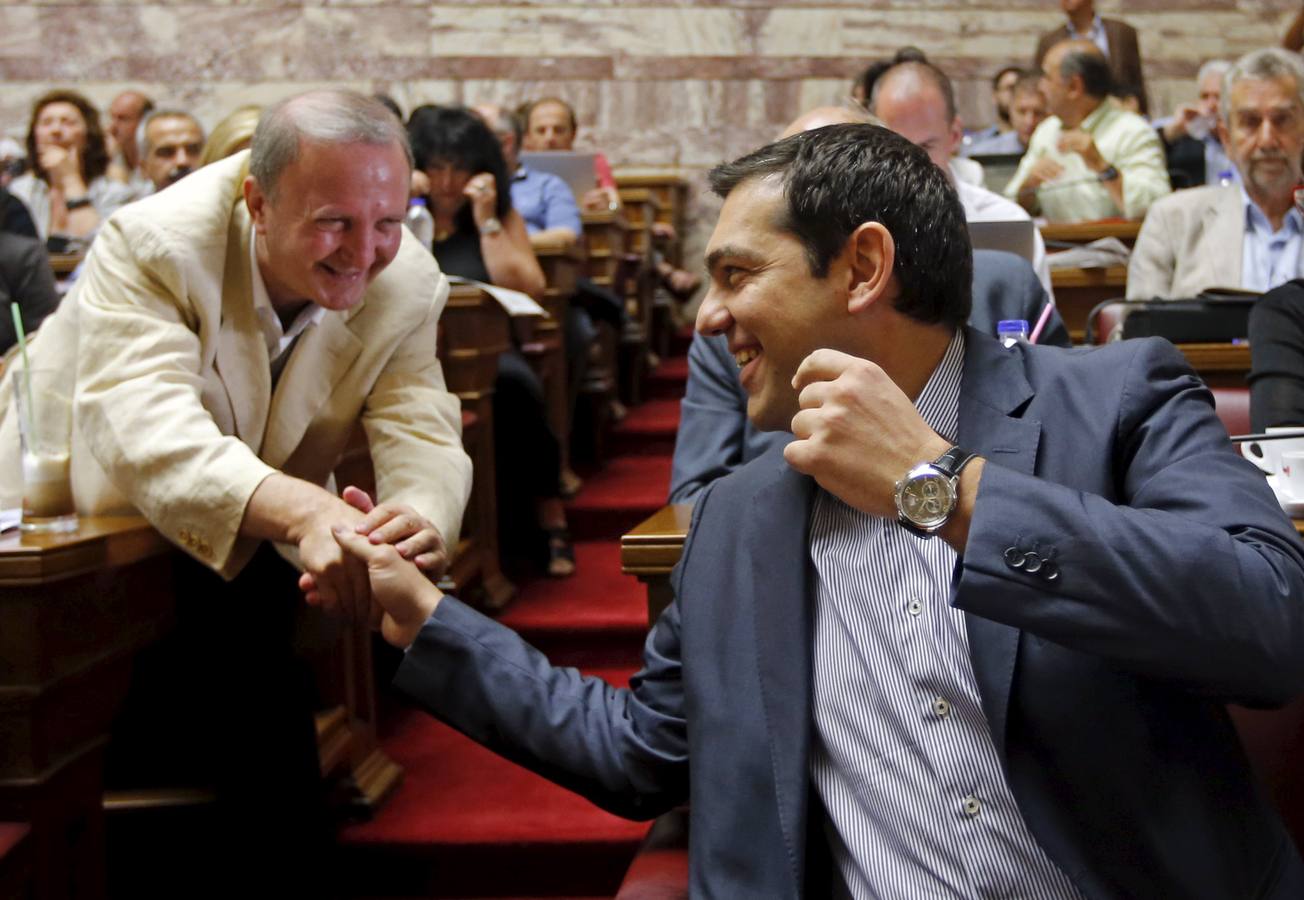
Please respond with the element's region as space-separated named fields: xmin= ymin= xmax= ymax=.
xmin=1128 ymin=185 xmax=1245 ymax=300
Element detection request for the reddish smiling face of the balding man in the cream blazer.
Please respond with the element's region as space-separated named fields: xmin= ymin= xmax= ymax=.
xmin=245 ymin=142 xmax=409 ymax=309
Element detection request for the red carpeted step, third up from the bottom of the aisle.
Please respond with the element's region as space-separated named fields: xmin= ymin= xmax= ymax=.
xmin=566 ymin=455 xmax=670 ymax=541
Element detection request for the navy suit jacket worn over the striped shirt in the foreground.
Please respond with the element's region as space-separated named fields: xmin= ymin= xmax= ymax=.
xmin=396 ymin=331 xmax=1304 ymax=900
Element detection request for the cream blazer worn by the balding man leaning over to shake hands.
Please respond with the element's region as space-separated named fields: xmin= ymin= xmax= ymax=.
xmin=0 ymin=153 xmax=471 ymax=578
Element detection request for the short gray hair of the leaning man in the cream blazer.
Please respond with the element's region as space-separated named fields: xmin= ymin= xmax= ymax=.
xmin=249 ymin=89 xmax=412 ymax=197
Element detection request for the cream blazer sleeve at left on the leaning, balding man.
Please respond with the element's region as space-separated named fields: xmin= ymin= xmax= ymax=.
xmin=68 ymin=217 xmax=275 ymax=578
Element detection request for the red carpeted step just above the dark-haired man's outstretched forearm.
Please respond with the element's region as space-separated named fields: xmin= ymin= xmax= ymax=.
xmin=498 ymin=540 xmax=648 ymax=668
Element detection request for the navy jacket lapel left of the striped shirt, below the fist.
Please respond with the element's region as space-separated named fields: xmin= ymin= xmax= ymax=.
xmin=742 ymin=459 xmax=815 ymax=884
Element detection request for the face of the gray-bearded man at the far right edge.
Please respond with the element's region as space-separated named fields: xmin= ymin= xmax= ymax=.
xmin=1219 ymin=77 xmax=1304 ymax=198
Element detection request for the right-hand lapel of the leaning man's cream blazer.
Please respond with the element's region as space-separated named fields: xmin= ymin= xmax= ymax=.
xmin=262 ymin=305 xmax=363 ymax=468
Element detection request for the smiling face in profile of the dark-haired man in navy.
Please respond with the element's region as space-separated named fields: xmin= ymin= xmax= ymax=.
xmin=696 ymin=179 xmax=849 ymax=430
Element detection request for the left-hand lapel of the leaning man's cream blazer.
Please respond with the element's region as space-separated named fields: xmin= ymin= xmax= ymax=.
xmin=213 ymin=198 xmax=271 ymax=453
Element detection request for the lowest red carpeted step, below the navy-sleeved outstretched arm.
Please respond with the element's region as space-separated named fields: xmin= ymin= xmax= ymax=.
xmin=340 ymin=668 xmax=648 ymax=897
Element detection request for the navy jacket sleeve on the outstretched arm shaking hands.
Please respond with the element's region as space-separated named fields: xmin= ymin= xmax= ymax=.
xmin=394 ymin=597 xmax=689 ymax=819
